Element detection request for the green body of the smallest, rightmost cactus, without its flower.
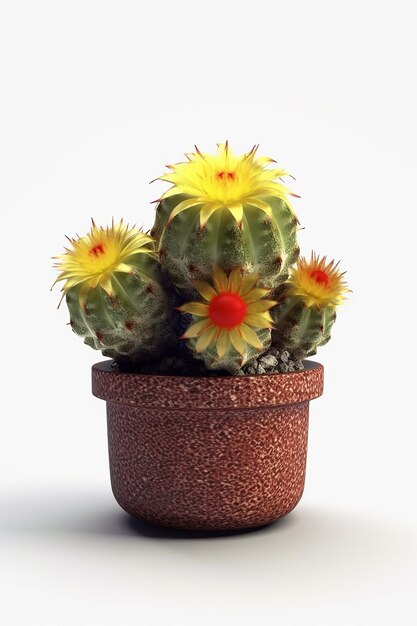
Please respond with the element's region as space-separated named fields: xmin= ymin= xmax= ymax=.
xmin=271 ymin=296 xmax=336 ymax=359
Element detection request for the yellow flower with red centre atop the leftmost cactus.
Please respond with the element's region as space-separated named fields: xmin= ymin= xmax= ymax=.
xmin=54 ymin=220 xmax=156 ymax=298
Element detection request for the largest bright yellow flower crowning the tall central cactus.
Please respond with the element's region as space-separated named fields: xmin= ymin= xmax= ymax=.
xmin=157 ymin=141 xmax=295 ymax=227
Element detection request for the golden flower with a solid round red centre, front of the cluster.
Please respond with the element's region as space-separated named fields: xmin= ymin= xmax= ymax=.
xmin=179 ymin=266 xmax=276 ymax=358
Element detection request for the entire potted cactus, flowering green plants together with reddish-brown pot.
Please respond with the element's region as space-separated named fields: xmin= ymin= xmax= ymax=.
xmin=52 ymin=143 xmax=348 ymax=530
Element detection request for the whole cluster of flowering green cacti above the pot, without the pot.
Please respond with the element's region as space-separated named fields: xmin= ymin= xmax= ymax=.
xmin=55 ymin=142 xmax=349 ymax=375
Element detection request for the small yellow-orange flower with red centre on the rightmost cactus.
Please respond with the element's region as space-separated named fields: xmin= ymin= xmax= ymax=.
xmin=288 ymin=252 xmax=350 ymax=308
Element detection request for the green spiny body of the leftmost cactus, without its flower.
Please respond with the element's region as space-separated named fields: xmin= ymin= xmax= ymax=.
xmin=66 ymin=254 xmax=174 ymax=363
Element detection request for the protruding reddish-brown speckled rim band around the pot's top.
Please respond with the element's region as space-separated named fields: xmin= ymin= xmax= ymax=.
xmin=92 ymin=360 xmax=323 ymax=411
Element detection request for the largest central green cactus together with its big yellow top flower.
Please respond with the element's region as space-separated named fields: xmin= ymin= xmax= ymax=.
xmin=151 ymin=142 xmax=299 ymax=293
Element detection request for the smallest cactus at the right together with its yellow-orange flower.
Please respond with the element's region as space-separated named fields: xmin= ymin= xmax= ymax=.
xmin=272 ymin=253 xmax=349 ymax=359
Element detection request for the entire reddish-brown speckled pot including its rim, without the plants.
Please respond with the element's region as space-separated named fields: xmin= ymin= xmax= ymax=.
xmin=93 ymin=361 xmax=323 ymax=530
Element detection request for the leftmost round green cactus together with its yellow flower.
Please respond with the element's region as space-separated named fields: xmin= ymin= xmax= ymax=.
xmin=52 ymin=221 xmax=173 ymax=363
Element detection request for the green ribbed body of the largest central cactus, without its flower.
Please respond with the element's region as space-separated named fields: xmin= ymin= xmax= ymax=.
xmin=151 ymin=195 xmax=299 ymax=293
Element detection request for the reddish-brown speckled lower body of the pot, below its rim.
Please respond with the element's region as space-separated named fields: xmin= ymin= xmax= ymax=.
xmin=108 ymin=402 xmax=308 ymax=530
